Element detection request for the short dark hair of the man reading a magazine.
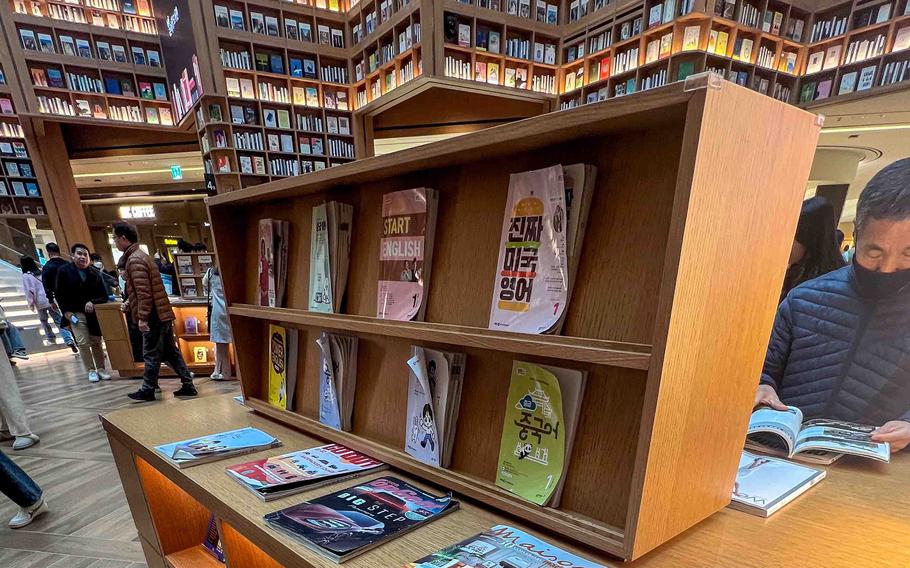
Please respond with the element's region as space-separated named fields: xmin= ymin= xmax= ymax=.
xmin=853 ymin=158 xmax=910 ymax=235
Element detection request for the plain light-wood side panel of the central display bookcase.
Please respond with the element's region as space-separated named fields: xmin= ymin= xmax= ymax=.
xmin=629 ymin=83 xmax=819 ymax=557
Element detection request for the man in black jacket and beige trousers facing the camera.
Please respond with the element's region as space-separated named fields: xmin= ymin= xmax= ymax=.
xmin=54 ymin=243 xmax=111 ymax=383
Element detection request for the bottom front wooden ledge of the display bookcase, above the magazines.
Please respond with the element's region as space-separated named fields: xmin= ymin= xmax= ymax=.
xmin=244 ymin=398 xmax=625 ymax=554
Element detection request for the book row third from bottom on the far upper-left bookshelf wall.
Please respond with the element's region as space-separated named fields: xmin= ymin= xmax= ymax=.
xmin=19 ymin=28 xmax=161 ymax=67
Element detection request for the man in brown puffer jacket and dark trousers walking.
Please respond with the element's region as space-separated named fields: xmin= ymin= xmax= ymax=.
xmin=114 ymin=222 xmax=197 ymax=402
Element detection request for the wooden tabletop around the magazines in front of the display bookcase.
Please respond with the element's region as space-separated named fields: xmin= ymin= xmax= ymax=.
xmin=102 ymin=396 xmax=613 ymax=568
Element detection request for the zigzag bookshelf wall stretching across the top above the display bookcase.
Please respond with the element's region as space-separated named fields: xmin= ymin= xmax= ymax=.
xmin=197 ymin=0 xmax=910 ymax=195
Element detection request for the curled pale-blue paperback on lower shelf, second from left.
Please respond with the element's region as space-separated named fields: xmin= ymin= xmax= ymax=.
xmin=316 ymin=332 xmax=358 ymax=432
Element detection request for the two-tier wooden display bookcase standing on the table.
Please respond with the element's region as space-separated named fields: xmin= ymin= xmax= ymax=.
xmin=208 ymin=74 xmax=820 ymax=559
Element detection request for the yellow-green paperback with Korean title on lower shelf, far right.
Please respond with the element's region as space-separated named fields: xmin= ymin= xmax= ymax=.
xmin=496 ymin=361 xmax=587 ymax=507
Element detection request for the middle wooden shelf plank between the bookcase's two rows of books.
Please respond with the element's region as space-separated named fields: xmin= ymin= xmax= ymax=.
xmin=230 ymin=304 xmax=651 ymax=370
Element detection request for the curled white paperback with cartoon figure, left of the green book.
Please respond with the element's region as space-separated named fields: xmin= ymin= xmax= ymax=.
xmin=404 ymin=346 xmax=465 ymax=467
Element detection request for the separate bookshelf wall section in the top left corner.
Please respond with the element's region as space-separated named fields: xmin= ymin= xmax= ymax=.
xmin=0 ymin=0 xmax=175 ymax=127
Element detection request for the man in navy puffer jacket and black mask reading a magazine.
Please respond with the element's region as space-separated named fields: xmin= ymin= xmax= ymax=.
xmin=755 ymin=158 xmax=910 ymax=451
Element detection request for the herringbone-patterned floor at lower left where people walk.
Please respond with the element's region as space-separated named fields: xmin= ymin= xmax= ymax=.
xmin=0 ymin=351 xmax=238 ymax=568
